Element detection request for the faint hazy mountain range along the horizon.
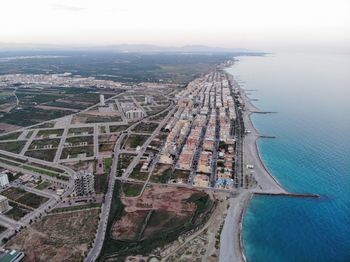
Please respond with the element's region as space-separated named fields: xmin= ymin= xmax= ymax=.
xmin=0 ymin=43 xmax=262 ymax=53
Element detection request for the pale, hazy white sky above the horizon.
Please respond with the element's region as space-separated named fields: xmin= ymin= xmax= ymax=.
xmin=0 ymin=0 xmax=350 ymax=50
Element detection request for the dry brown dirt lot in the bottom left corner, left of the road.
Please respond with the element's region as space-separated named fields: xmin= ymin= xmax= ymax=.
xmin=6 ymin=209 xmax=100 ymax=262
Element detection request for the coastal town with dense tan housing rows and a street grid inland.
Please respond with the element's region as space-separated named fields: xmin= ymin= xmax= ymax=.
xmin=0 ymin=62 xmax=255 ymax=261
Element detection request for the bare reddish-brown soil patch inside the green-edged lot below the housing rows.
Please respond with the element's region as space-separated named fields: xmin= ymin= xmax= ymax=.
xmin=112 ymin=186 xmax=206 ymax=240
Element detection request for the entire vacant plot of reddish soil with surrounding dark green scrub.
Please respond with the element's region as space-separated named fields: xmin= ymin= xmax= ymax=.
xmin=102 ymin=182 xmax=213 ymax=261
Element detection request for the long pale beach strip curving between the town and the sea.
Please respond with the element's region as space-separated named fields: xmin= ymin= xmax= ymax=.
xmin=220 ymin=75 xmax=288 ymax=262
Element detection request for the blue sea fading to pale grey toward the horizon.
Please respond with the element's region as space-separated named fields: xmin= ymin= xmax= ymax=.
xmin=228 ymin=53 xmax=350 ymax=262
